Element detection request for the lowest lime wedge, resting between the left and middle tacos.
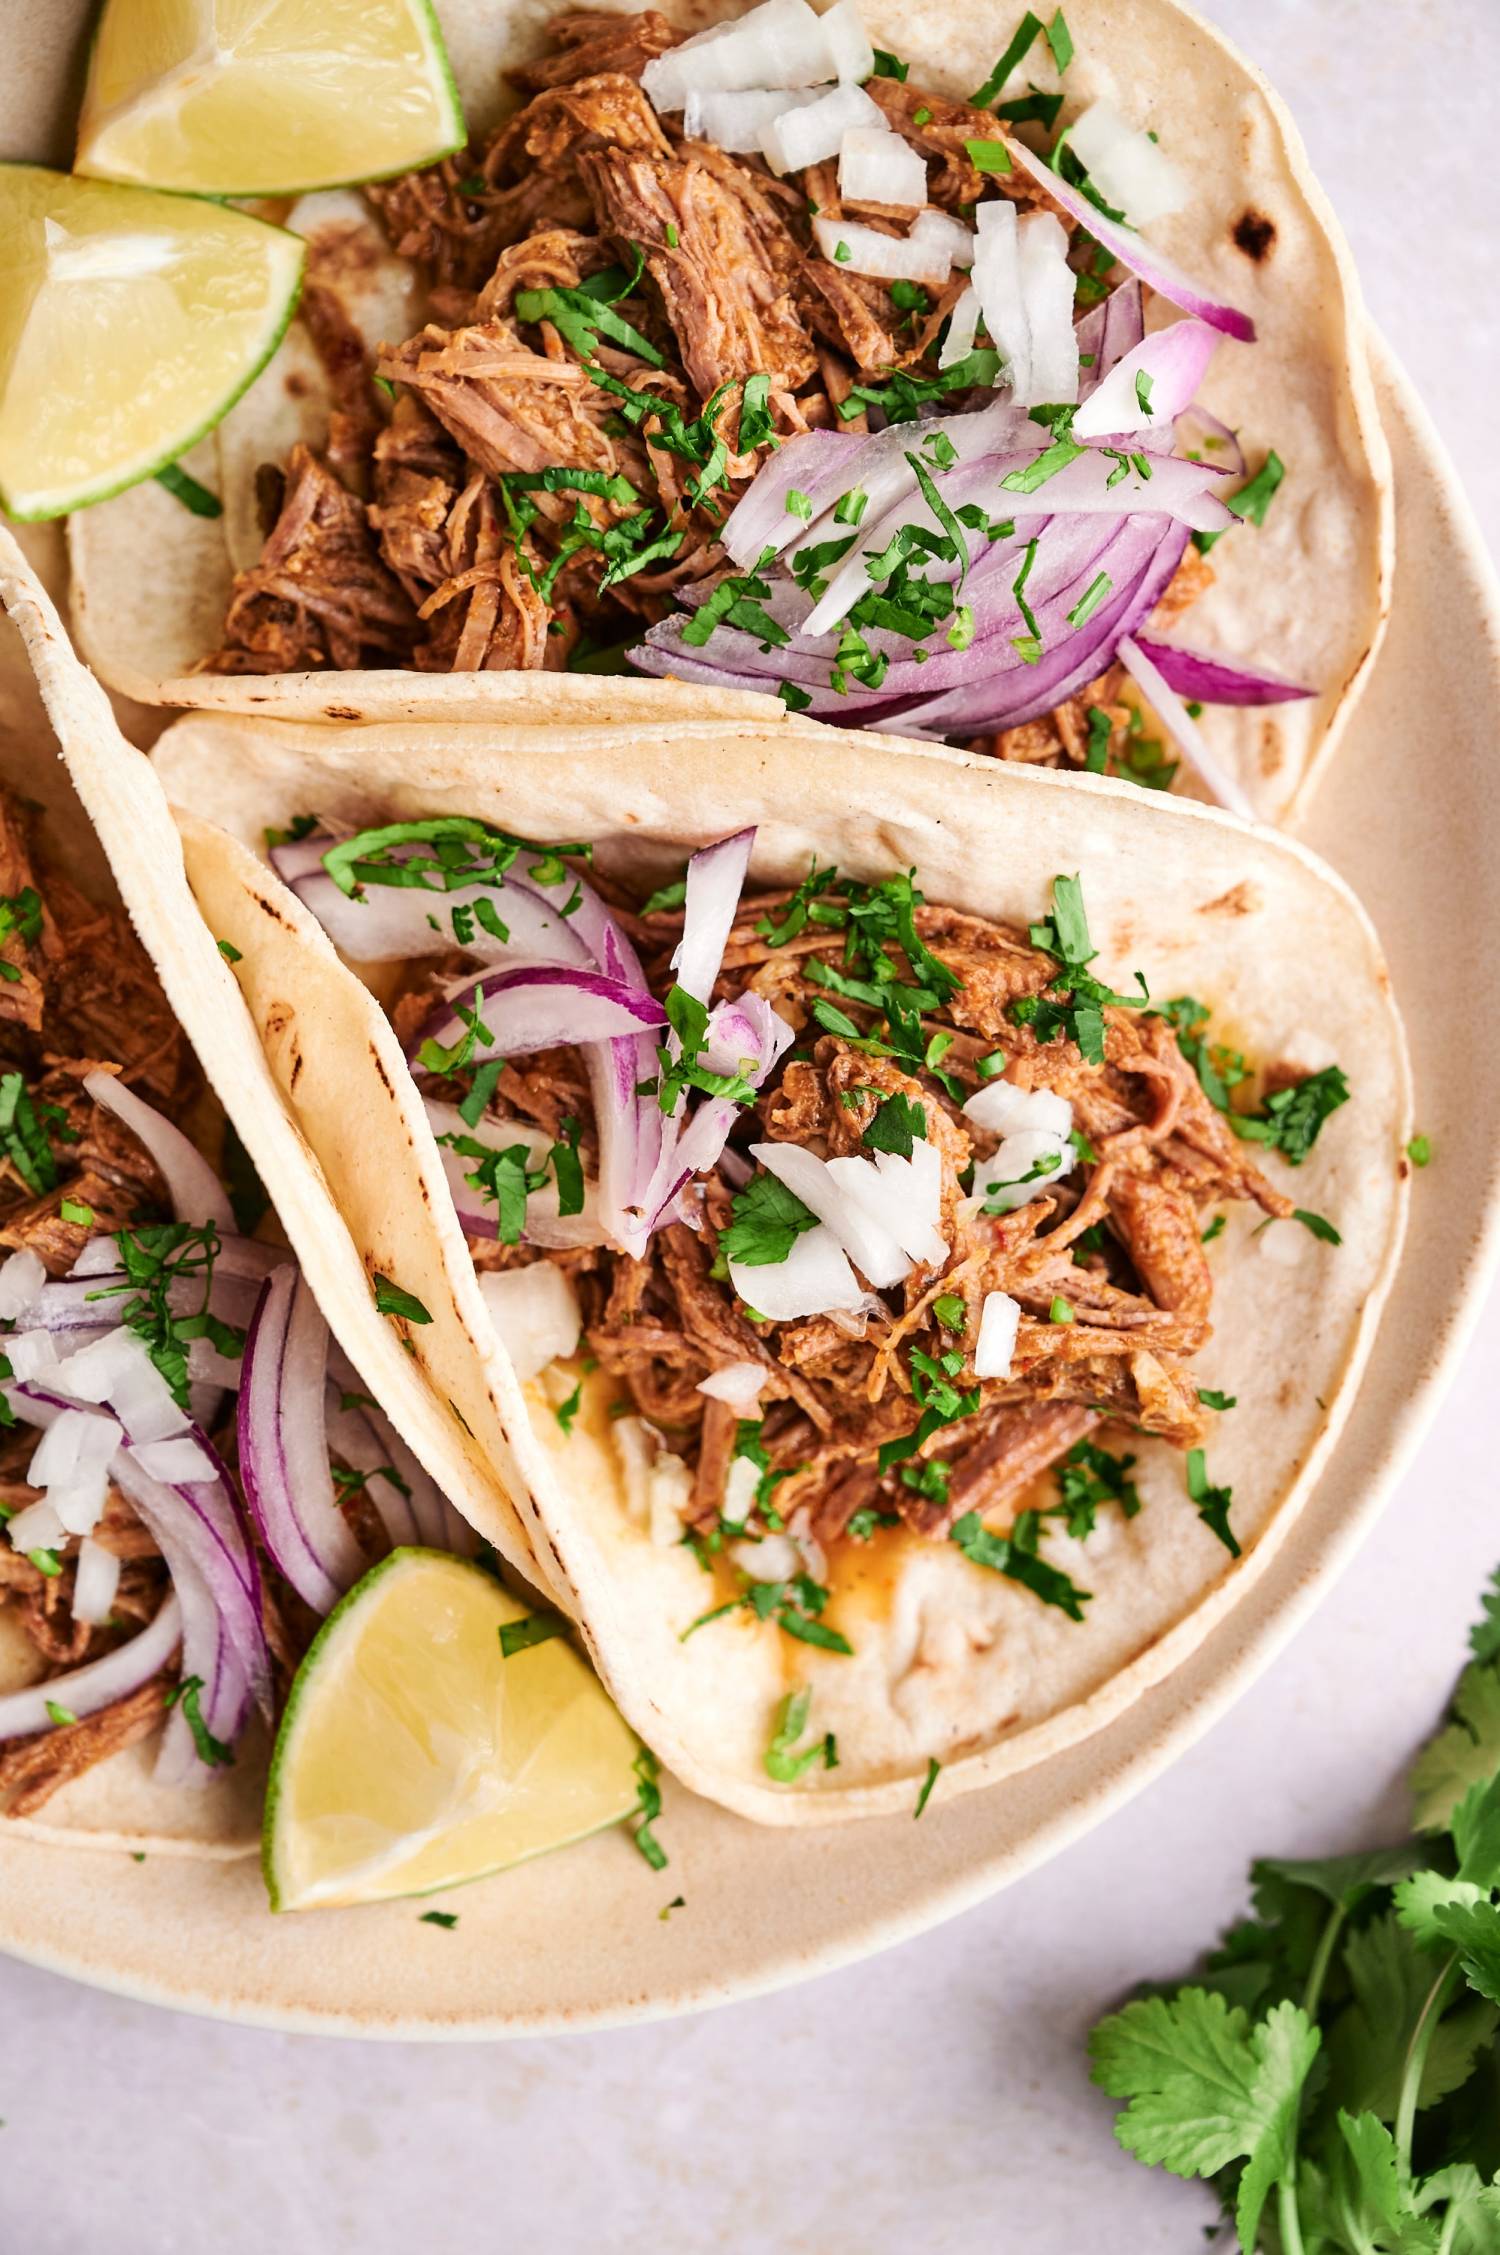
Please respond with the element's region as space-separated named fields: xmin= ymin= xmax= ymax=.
xmin=264 ymin=1549 xmax=638 ymax=1910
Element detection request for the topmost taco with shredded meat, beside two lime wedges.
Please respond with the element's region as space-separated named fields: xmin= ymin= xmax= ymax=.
xmin=61 ymin=0 xmax=1392 ymax=819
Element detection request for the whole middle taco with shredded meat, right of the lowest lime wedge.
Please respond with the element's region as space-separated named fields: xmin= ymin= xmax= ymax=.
xmin=117 ymin=694 xmax=1408 ymax=1824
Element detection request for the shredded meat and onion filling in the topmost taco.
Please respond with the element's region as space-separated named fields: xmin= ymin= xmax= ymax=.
xmin=205 ymin=0 xmax=1329 ymax=807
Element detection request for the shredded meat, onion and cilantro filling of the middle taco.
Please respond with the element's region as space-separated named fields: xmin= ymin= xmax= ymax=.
xmin=271 ymin=816 xmax=1349 ymax=1653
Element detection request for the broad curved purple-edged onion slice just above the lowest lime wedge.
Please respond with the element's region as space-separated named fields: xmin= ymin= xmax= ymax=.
xmin=239 ymin=1265 xmax=365 ymax=1615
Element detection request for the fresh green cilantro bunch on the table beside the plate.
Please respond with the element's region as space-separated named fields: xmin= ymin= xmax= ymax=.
xmin=1089 ymin=1572 xmax=1500 ymax=2255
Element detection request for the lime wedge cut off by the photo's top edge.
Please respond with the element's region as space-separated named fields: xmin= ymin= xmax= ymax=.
xmin=77 ymin=0 xmax=465 ymax=196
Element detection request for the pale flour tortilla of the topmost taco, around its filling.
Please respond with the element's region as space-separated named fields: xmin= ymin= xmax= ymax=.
xmin=70 ymin=0 xmax=1392 ymax=821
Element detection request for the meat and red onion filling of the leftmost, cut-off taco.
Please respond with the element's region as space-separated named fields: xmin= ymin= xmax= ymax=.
xmin=0 ymin=794 xmax=474 ymax=1818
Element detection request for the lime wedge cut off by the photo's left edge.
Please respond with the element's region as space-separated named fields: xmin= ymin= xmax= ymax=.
xmin=0 ymin=165 xmax=305 ymax=519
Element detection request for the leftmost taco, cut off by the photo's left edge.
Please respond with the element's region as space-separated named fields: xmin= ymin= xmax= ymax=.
xmin=0 ymin=537 xmax=595 ymax=1858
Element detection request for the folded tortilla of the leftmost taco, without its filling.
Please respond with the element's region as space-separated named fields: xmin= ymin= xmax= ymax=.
xmin=0 ymin=528 xmax=571 ymax=1856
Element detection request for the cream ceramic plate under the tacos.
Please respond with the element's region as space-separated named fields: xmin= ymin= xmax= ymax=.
xmin=0 ymin=338 xmax=1500 ymax=2039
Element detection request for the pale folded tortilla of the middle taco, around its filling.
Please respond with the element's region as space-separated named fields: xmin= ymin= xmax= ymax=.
xmin=125 ymin=694 xmax=1410 ymax=1824
